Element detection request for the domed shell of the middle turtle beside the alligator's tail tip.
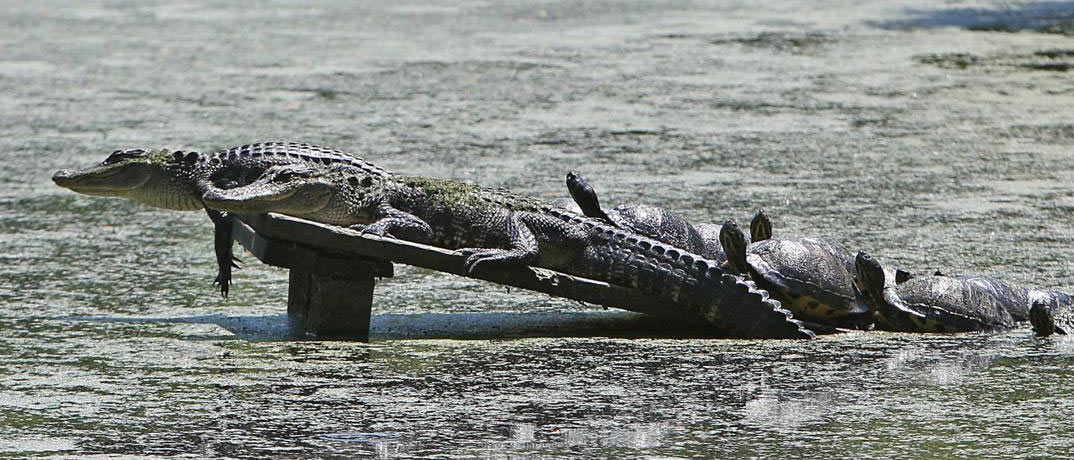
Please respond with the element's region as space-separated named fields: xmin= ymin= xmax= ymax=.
xmin=746 ymin=239 xmax=871 ymax=326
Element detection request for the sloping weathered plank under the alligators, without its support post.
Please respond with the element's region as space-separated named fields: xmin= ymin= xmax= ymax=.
xmin=236 ymin=214 xmax=683 ymax=316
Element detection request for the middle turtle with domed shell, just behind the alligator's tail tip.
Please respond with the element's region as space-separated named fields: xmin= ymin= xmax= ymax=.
xmin=720 ymin=218 xmax=873 ymax=329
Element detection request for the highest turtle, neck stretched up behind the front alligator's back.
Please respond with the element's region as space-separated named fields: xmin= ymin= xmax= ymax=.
xmin=567 ymin=171 xmax=725 ymax=262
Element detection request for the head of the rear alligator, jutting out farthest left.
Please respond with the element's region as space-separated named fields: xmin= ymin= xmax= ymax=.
xmin=53 ymin=148 xmax=202 ymax=211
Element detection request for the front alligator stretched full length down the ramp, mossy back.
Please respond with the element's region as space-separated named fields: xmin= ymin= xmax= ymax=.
xmin=203 ymin=166 xmax=814 ymax=339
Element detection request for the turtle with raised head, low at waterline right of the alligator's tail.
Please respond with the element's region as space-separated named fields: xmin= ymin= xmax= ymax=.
xmin=855 ymin=251 xmax=1014 ymax=332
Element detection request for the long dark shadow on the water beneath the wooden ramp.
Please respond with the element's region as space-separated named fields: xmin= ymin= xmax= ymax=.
xmin=61 ymin=311 xmax=713 ymax=342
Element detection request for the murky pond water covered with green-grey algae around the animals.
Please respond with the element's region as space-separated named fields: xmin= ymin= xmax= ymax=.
xmin=0 ymin=1 xmax=1074 ymax=458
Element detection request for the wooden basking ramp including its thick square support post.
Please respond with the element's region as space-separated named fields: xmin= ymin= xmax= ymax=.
xmin=233 ymin=214 xmax=679 ymax=337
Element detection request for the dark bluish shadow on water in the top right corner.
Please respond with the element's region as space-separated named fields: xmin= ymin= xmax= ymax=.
xmin=871 ymin=1 xmax=1074 ymax=35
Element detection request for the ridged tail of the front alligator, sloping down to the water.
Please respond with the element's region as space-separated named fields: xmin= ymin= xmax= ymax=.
xmin=546 ymin=209 xmax=815 ymax=339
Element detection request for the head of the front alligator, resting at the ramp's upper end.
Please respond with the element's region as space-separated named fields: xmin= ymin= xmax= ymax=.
xmin=202 ymin=164 xmax=339 ymax=217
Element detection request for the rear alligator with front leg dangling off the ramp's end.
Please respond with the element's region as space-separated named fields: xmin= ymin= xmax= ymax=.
xmin=53 ymin=142 xmax=391 ymax=297
